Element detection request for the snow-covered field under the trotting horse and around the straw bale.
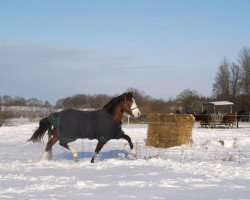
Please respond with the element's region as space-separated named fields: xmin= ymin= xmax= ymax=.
xmin=0 ymin=120 xmax=250 ymax=200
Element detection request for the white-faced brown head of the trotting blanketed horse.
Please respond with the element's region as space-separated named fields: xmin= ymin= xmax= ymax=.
xmin=121 ymin=92 xmax=141 ymax=118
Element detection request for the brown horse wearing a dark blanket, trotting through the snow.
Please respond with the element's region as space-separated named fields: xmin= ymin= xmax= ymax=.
xmin=28 ymin=92 xmax=141 ymax=163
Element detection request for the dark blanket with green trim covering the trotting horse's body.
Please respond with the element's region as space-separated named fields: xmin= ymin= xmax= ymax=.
xmin=48 ymin=109 xmax=124 ymax=144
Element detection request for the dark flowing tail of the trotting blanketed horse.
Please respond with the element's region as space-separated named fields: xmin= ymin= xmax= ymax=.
xmin=28 ymin=117 xmax=52 ymax=142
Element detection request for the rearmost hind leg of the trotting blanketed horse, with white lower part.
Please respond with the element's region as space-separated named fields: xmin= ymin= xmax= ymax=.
xmin=40 ymin=129 xmax=58 ymax=161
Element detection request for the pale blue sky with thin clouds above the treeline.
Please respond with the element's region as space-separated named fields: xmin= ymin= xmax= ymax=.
xmin=0 ymin=0 xmax=250 ymax=103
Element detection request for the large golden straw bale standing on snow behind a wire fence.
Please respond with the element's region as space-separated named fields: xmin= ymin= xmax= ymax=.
xmin=146 ymin=113 xmax=195 ymax=148
